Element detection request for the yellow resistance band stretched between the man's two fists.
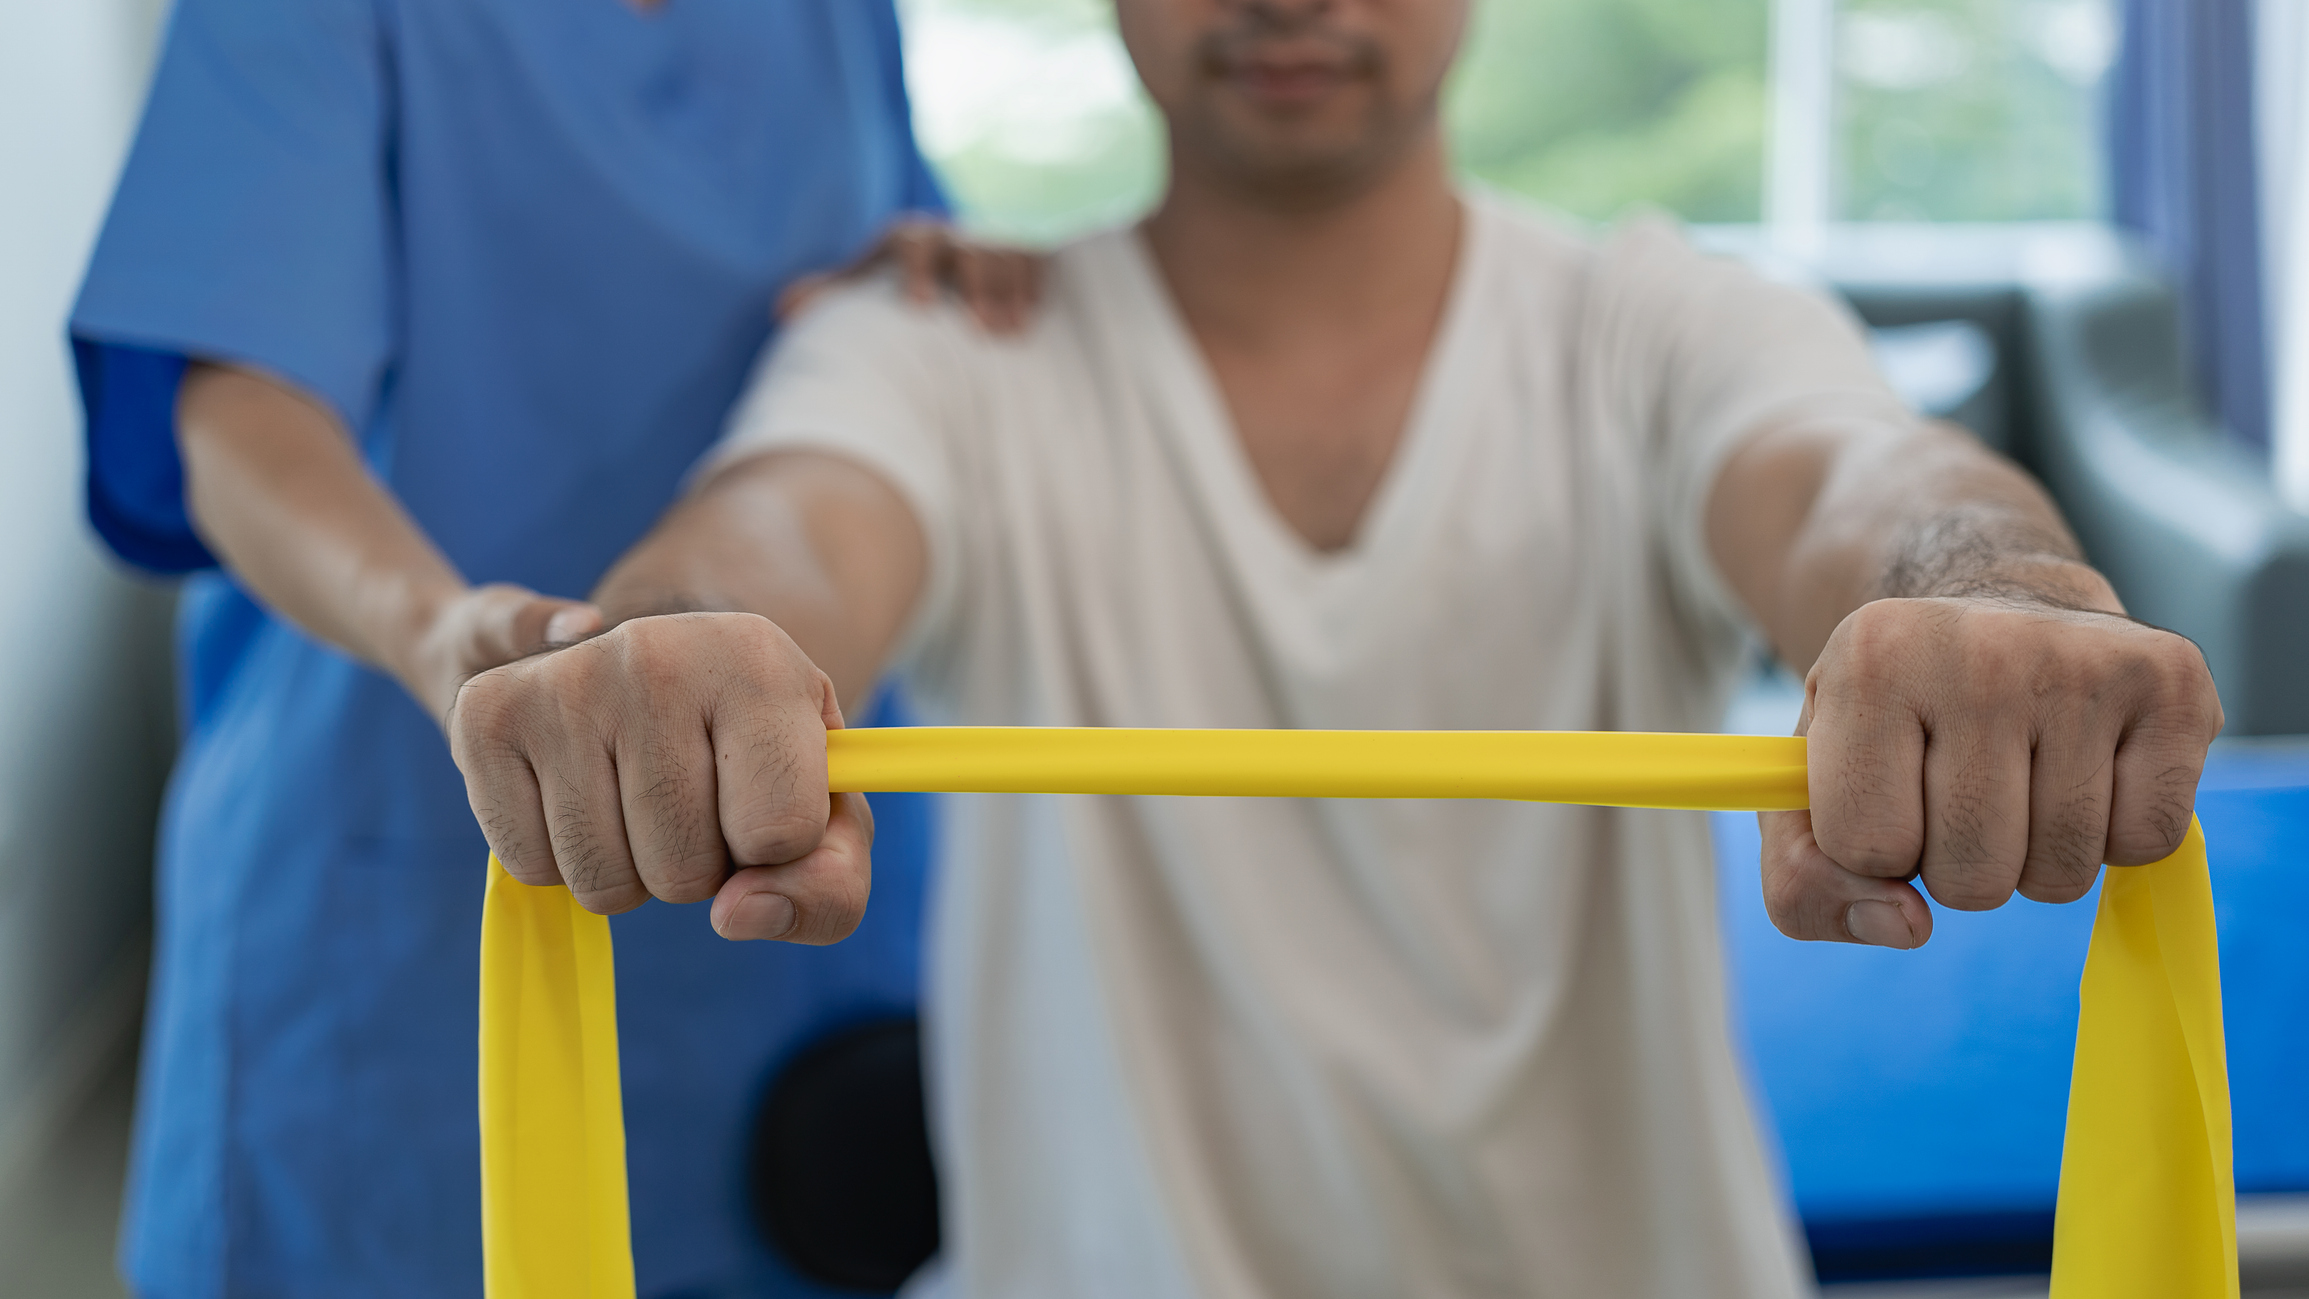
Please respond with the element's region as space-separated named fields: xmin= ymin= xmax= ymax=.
xmin=480 ymin=727 xmax=2237 ymax=1299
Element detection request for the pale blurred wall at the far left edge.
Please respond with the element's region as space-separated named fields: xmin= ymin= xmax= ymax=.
xmin=0 ymin=0 xmax=173 ymax=1184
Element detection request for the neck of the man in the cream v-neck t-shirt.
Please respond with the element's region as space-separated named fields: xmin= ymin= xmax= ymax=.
xmin=1143 ymin=136 xmax=1462 ymax=348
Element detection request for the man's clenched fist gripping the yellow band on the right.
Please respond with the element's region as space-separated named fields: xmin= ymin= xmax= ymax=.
xmin=1762 ymin=598 xmax=2221 ymax=948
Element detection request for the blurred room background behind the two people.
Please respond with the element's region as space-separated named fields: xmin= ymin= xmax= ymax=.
xmin=0 ymin=0 xmax=2309 ymax=1299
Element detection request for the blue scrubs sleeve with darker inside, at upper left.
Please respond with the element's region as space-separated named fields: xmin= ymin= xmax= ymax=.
xmin=72 ymin=0 xmax=395 ymax=572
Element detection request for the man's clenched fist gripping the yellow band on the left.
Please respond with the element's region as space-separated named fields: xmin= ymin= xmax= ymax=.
xmin=448 ymin=614 xmax=873 ymax=944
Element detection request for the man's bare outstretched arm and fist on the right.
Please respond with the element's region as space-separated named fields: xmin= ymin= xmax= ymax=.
xmin=1706 ymin=422 xmax=2221 ymax=948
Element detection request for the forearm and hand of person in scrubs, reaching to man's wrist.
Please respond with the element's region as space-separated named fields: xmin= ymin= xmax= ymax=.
xmin=175 ymin=365 xmax=591 ymax=720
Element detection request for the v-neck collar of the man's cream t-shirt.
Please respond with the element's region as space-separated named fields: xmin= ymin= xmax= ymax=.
xmin=1118 ymin=196 xmax=1492 ymax=575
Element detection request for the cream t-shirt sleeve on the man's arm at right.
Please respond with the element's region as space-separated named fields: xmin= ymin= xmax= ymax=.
xmin=1602 ymin=217 xmax=1914 ymax=628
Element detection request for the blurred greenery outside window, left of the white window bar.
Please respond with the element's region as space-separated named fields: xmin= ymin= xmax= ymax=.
xmin=905 ymin=0 xmax=1766 ymax=240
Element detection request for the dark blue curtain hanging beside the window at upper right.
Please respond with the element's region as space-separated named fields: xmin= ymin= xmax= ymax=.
xmin=2108 ymin=0 xmax=2270 ymax=448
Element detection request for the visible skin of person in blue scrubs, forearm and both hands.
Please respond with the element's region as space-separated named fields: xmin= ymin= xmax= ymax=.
xmin=175 ymin=217 xmax=1039 ymax=733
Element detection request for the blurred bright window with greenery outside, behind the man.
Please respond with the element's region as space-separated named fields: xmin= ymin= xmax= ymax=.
xmin=901 ymin=0 xmax=2115 ymax=242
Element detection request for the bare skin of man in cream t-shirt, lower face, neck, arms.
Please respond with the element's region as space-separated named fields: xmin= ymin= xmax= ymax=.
xmin=450 ymin=0 xmax=2221 ymax=946
